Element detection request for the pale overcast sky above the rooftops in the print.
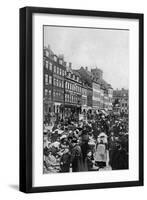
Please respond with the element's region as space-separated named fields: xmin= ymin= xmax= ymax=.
xmin=44 ymin=26 xmax=129 ymax=89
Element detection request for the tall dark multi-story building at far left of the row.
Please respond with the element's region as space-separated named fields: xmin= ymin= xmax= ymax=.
xmin=43 ymin=47 xmax=66 ymax=121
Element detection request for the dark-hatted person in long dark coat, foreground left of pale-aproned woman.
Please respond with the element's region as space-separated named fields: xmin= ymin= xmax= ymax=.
xmin=71 ymin=137 xmax=82 ymax=172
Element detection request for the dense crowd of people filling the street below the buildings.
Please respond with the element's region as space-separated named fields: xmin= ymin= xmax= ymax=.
xmin=43 ymin=112 xmax=129 ymax=173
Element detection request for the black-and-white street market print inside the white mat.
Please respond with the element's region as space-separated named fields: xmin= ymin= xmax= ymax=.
xmin=42 ymin=25 xmax=130 ymax=174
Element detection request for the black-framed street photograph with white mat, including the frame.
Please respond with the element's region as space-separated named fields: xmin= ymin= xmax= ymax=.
xmin=20 ymin=7 xmax=143 ymax=193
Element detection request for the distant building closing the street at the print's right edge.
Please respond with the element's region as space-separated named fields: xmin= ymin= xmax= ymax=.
xmin=113 ymin=88 xmax=129 ymax=114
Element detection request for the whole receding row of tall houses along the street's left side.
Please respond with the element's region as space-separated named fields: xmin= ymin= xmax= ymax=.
xmin=43 ymin=46 xmax=113 ymax=121
